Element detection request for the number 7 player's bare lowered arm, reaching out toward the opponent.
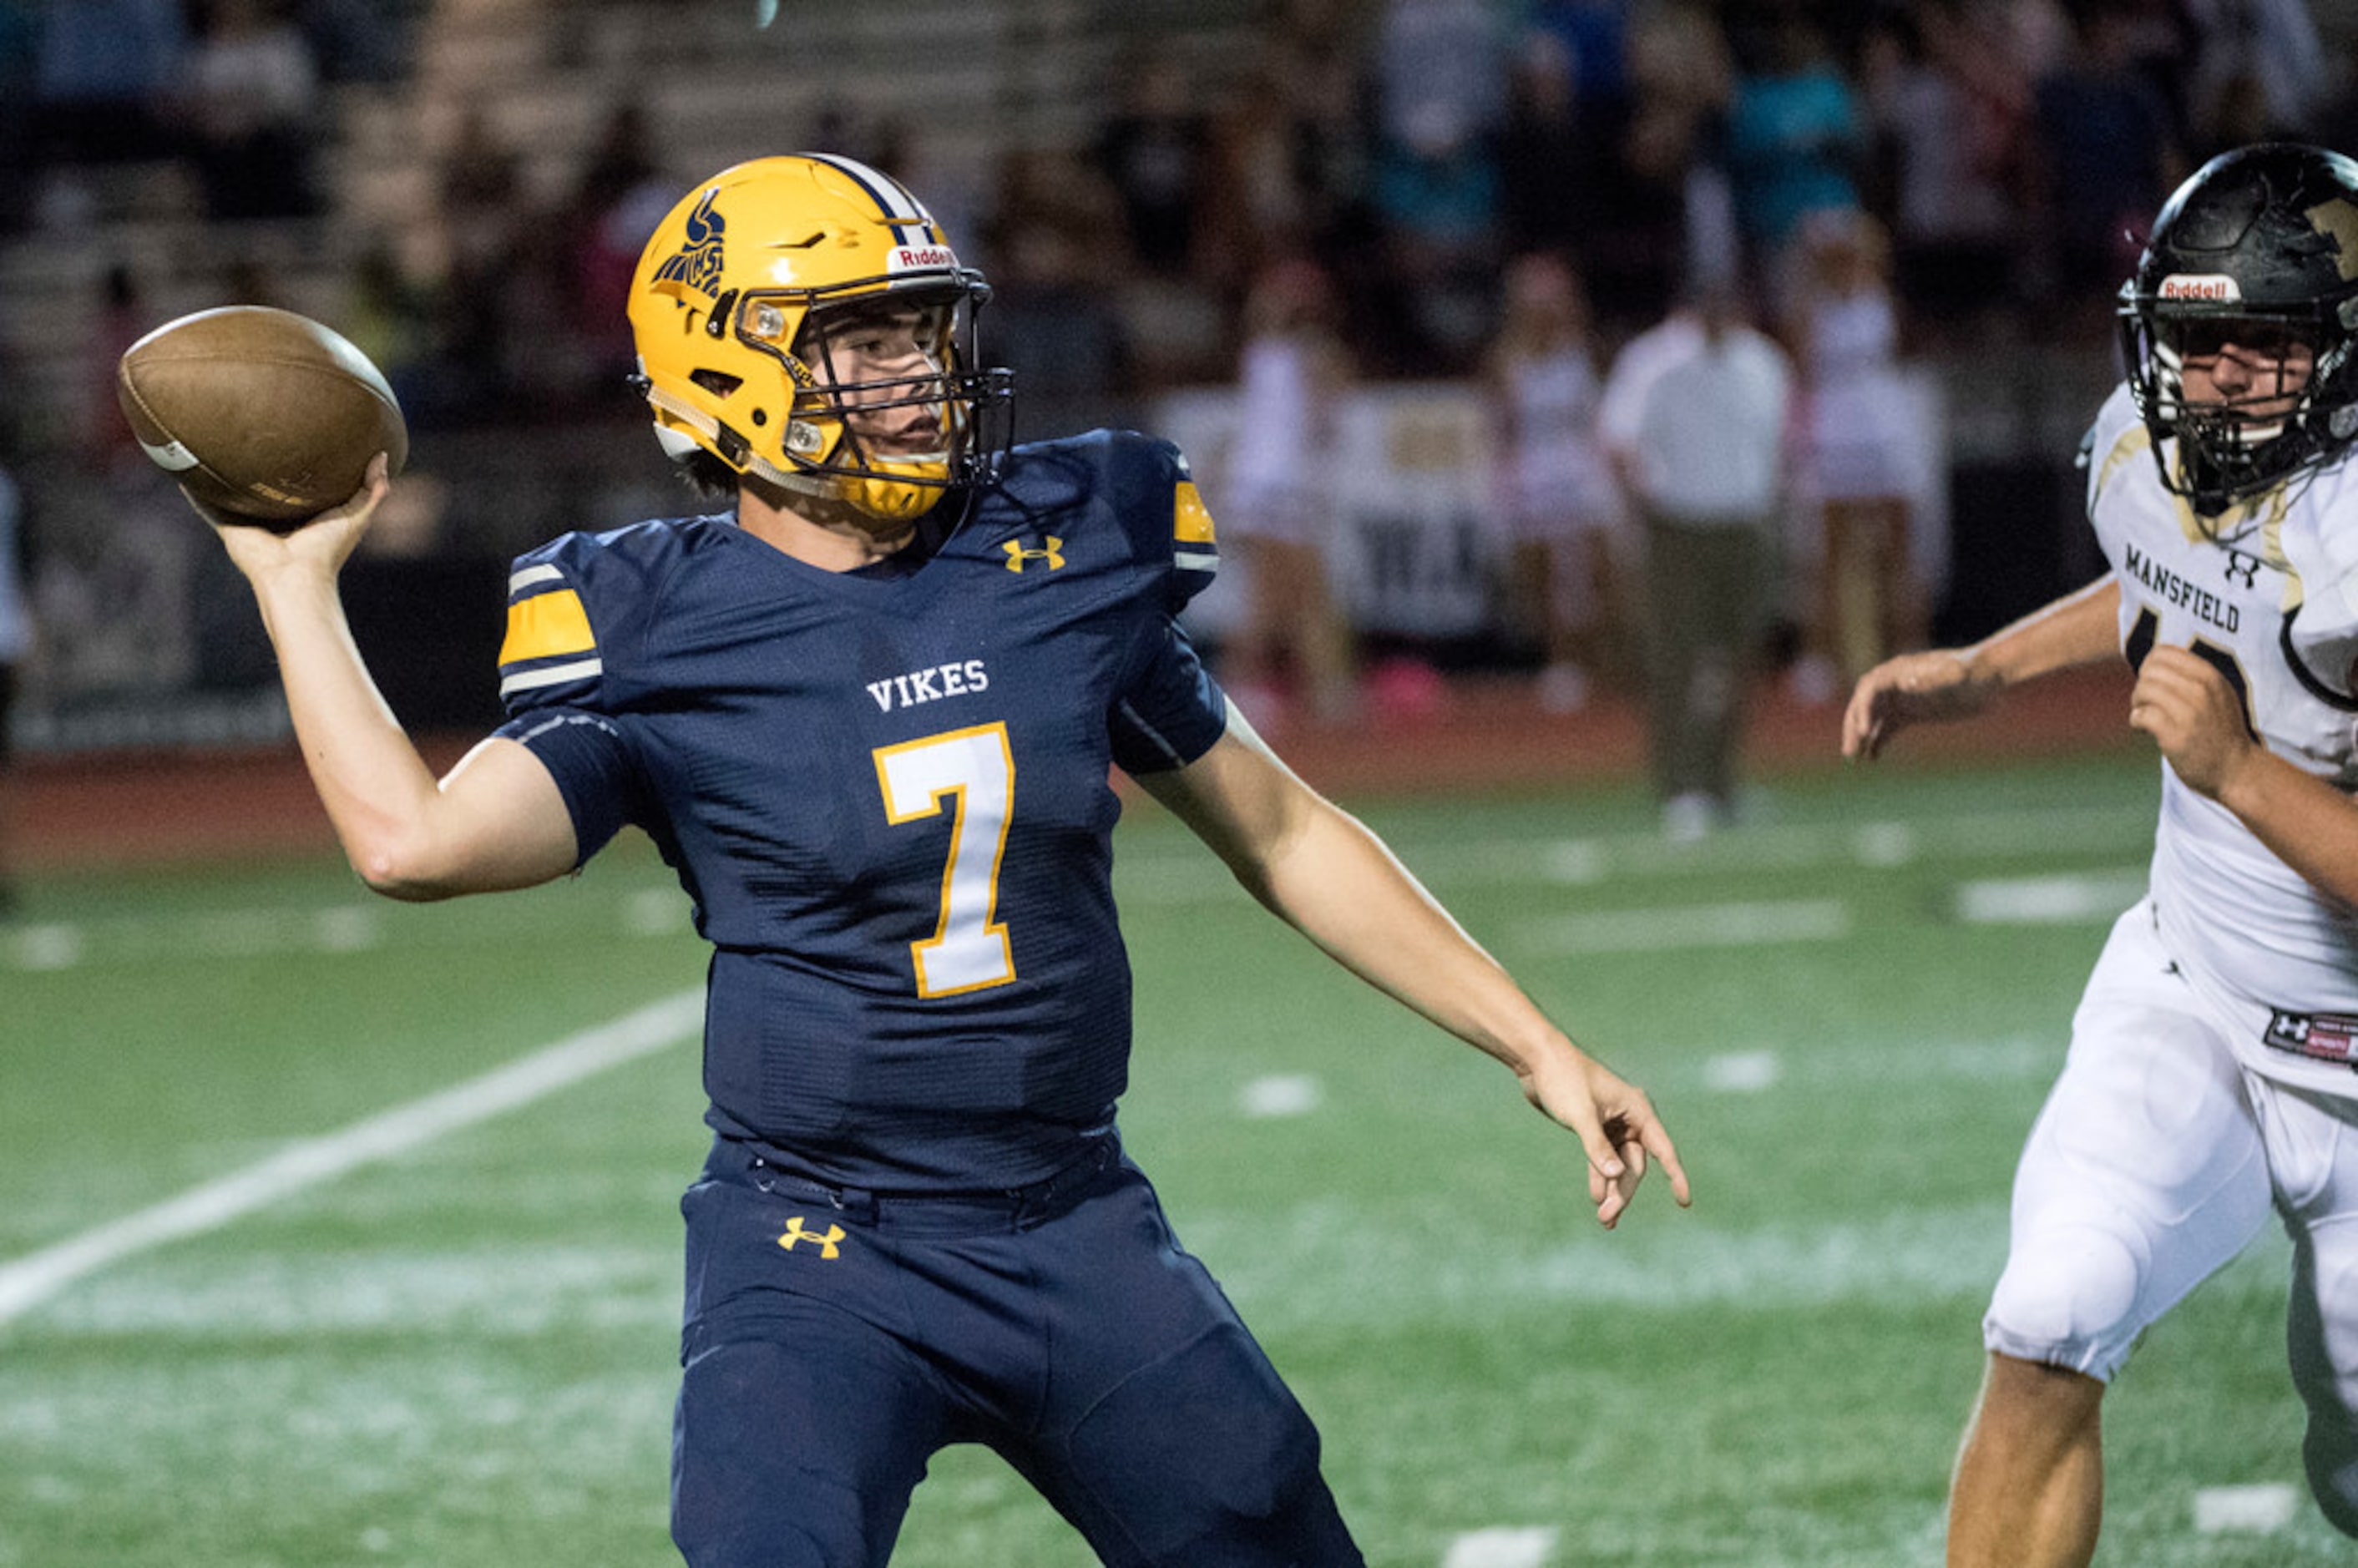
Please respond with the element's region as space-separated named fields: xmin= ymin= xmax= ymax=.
xmin=1139 ymin=705 xmax=1688 ymax=1228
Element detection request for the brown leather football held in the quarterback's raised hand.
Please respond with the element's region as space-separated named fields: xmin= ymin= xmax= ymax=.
xmin=115 ymin=304 xmax=410 ymax=530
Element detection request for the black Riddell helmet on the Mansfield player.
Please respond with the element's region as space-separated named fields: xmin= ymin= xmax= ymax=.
xmin=2118 ymin=141 xmax=2358 ymax=516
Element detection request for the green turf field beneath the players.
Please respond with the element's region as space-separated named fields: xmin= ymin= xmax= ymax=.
xmin=0 ymin=759 xmax=2351 ymax=1568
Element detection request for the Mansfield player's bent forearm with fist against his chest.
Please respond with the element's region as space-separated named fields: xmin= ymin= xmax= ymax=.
xmin=2129 ymin=644 xmax=2358 ymax=903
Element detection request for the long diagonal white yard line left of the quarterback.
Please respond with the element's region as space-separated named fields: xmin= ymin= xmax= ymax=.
xmin=0 ymin=990 xmax=705 ymax=1323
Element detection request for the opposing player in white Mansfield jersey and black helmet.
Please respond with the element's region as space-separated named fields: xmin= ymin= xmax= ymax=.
xmin=1842 ymin=144 xmax=2358 ymax=1568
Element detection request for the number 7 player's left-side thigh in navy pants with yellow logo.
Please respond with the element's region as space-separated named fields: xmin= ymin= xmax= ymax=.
xmin=672 ymin=1160 xmax=948 ymax=1568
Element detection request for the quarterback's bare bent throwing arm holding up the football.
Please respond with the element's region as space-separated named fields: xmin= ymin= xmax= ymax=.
xmin=205 ymin=458 xmax=575 ymax=898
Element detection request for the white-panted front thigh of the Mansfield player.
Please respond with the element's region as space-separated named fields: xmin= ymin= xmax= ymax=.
xmin=1983 ymin=905 xmax=2269 ymax=1379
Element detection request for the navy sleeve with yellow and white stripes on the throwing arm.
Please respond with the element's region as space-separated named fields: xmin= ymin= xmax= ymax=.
xmin=495 ymin=535 xmax=644 ymax=861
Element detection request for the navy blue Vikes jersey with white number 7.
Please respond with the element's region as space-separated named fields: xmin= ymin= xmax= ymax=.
xmin=500 ymin=432 xmax=1226 ymax=1191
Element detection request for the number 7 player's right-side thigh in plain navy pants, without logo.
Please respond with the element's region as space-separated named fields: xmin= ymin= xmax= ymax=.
xmin=1007 ymin=1170 xmax=1360 ymax=1568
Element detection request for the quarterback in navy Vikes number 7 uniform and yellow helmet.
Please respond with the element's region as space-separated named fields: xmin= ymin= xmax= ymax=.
xmin=193 ymin=155 xmax=1688 ymax=1568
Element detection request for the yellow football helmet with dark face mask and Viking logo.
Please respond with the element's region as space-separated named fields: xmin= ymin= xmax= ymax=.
xmin=630 ymin=154 xmax=1011 ymax=521
